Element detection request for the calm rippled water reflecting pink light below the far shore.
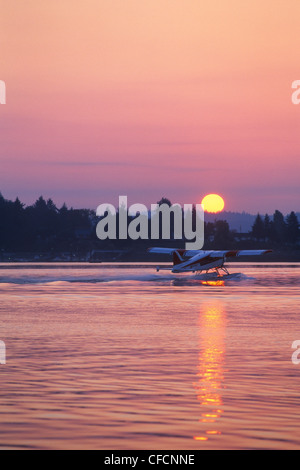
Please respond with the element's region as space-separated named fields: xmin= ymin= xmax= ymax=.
xmin=0 ymin=264 xmax=300 ymax=449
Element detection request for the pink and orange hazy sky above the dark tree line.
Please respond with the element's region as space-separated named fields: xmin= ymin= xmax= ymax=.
xmin=0 ymin=0 xmax=300 ymax=213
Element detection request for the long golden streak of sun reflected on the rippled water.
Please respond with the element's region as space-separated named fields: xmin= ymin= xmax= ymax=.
xmin=194 ymin=302 xmax=226 ymax=441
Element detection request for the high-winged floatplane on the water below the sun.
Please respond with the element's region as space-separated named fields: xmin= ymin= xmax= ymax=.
xmin=148 ymin=248 xmax=272 ymax=276
